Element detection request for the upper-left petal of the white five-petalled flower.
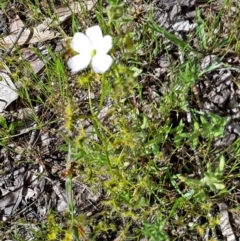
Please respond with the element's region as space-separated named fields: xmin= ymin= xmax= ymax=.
xmin=70 ymin=33 xmax=92 ymax=54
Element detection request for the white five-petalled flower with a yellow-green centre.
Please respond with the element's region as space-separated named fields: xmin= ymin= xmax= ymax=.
xmin=67 ymin=26 xmax=113 ymax=74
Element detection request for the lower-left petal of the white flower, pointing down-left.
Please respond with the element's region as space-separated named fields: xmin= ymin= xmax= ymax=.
xmin=67 ymin=54 xmax=91 ymax=73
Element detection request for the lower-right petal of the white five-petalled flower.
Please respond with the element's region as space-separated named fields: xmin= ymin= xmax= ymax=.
xmin=92 ymin=54 xmax=113 ymax=74
